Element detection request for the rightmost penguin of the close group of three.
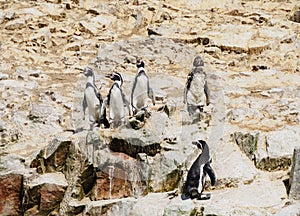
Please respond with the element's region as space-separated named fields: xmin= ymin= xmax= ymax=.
xmin=131 ymin=60 xmax=155 ymax=115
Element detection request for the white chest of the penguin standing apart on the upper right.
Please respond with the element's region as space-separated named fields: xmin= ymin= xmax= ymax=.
xmin=187 ymin=74 xmax=205 ymax=106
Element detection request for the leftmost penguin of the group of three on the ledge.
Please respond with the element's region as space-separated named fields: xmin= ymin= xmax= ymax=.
xmin=82 ymin=67 xmax=103 ymax=129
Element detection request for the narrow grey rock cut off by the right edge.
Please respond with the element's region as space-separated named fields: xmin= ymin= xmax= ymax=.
xmin=289 ymin=147 xmax=300 ymax=200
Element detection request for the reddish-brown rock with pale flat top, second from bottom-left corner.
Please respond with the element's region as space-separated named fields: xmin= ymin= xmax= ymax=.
xmin=23 ymin=173 xmax=68 ymax=215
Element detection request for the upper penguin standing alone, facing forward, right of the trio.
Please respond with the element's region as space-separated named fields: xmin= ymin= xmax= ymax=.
xmin=183 ymin=56 xmax=210 ymax=116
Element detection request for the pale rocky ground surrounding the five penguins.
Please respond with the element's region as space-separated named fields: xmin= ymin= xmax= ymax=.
xmin=0 ymin=0 xmax=300 ymax=216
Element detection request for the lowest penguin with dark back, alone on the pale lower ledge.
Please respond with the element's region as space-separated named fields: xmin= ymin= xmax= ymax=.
xmin=183 ymin=140 xmax=216 ymax=199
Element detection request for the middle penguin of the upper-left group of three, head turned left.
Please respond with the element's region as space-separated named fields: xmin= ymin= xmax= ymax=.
xmin=101 ymin=72 xmax=129 ymax=128
